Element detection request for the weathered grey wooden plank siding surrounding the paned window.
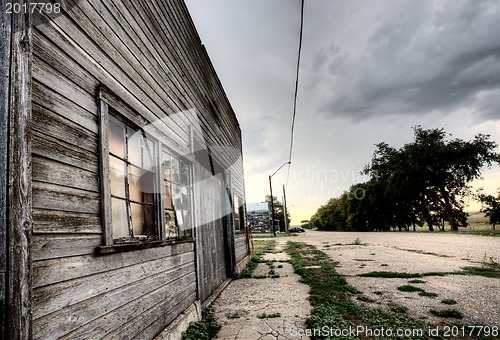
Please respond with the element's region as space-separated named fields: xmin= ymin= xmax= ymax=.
xmin=32 ymin=0 xmax=246 ymax=339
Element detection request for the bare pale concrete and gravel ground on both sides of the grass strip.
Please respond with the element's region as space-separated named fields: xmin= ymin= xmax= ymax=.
xmin=215 ymin=231 xmax=500 ymax=340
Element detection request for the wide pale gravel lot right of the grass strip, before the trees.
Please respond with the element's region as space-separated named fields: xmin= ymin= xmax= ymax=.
xmin=294 ymin=231 xmax=500 ymax=327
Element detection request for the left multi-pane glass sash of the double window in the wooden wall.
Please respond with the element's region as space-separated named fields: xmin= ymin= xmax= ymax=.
xmin=108 ymin=116 xmax=160 ymax=241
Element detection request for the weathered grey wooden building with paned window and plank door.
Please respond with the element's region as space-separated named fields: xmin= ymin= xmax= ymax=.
xmin=0 ymin=0 xmax=248 ymax=339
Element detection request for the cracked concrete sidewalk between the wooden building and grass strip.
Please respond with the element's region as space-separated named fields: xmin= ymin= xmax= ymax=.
xmin=213 ymin=242 xmax=311 ymax=340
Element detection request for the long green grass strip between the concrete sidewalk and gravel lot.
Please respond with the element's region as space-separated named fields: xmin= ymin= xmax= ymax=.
xmin=286 ymin=242 xmax=427 ymax=339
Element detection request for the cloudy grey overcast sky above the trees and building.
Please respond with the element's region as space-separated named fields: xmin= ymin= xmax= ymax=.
xmin=186 ymin=0 xmax=500 ymax=224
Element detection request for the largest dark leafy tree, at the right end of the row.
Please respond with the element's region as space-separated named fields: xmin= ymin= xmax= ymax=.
xmin=364 ymin=126 xmax=500 ymax=230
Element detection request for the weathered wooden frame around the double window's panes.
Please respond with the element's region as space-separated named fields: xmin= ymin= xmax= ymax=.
xmin=96 ymin=86 xmax=195 ymax=254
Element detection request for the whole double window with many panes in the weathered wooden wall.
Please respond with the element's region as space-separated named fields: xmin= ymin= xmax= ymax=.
xmin=100 ymin=89 xmax=193 ymax=249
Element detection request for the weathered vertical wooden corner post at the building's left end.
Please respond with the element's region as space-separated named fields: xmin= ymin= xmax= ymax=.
xmin=0 ymin=0 xmax=32 ymax=339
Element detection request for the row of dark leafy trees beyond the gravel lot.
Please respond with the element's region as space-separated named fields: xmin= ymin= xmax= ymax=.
xmin=309 ymin=126 xmax=500 ymax=231
